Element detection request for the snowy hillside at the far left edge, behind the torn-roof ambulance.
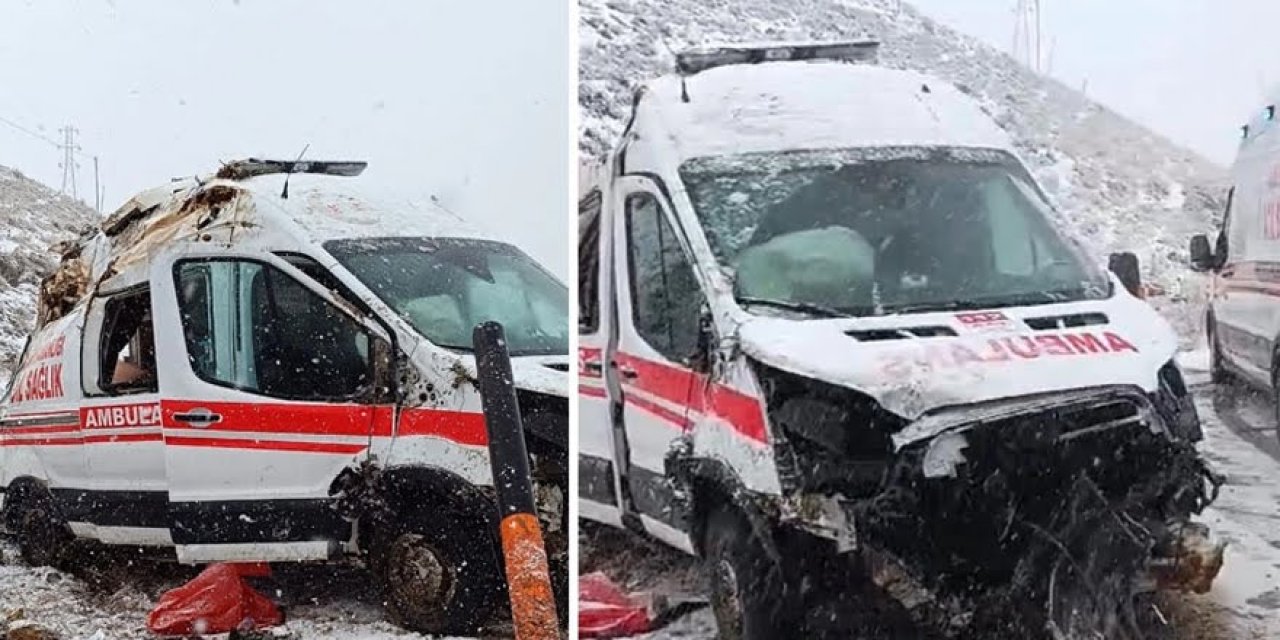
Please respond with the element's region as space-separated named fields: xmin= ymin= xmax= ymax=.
xmin=0 ymin=166 xmax=97 ymax=373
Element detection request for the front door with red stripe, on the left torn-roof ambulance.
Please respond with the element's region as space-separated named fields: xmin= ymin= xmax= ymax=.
xmin=152 ymin=255 xmax=393 ymax=563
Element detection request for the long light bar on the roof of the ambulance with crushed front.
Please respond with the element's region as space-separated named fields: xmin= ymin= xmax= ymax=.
xmin=676 ymin=40 xmax=879 ymax=76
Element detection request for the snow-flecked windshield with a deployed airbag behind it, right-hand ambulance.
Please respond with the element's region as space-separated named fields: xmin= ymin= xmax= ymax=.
xmin=680 ymin=147 xmax=1111 ymax=315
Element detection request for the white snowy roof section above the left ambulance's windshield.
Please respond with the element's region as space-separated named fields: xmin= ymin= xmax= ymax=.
xmin=236 ymin=174 xmax=495 ymax=242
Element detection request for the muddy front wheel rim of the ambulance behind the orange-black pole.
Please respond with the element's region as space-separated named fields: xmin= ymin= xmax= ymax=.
xmin=387 ymin=534 xmax=457 ymax=614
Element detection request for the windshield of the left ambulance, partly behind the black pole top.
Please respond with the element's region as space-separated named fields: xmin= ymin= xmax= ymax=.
xmin=325 ymin=238 xmax=568 ymax=356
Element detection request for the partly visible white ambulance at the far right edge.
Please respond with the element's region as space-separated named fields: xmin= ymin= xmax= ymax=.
xmin=1190 ymin=105 xmax=1280 ymax=417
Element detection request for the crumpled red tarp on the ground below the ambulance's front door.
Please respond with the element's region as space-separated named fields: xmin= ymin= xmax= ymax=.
xmin=147 ymin=563 xmax=284 ymax=636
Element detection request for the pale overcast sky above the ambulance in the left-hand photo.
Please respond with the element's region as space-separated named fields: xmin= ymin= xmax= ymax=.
xmin=0 ymin=0 xmax=570 ymax=276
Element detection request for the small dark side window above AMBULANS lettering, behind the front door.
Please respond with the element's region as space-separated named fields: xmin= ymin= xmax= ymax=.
xmin=97 ymin=292 xmax=159 ymax=394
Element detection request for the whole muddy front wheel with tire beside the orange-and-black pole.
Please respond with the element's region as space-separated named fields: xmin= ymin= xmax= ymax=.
xmin=370 ymin=513 xmax=506 ymax=635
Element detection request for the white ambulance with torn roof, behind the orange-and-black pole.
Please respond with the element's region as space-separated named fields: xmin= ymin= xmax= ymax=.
xmin=0 ymin=160 xmax=568 ymax=631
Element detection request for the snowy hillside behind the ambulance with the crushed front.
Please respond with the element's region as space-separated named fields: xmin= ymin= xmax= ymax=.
xmin=579 ymin=0 xmax=1233 ymax=335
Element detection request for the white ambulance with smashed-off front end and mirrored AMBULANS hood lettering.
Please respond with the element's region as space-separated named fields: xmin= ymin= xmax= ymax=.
xmin=577 ymin=42 xmax=1221 ymax=639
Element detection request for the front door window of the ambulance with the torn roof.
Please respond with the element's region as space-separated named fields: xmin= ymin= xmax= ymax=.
xmin=177 ymin=260 xmax=371 ymax=399
